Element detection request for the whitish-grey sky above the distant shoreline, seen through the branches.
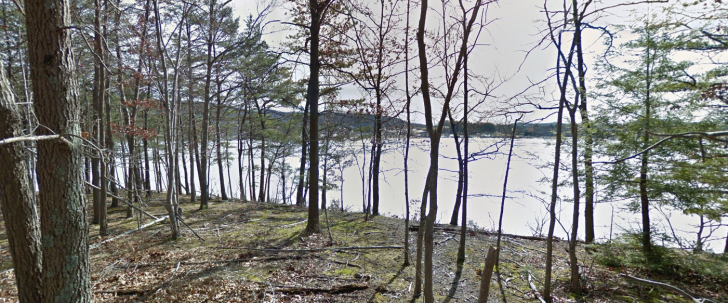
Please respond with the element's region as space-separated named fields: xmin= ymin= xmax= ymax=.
xmin=231 ymin=0 xmax=720 ymax=123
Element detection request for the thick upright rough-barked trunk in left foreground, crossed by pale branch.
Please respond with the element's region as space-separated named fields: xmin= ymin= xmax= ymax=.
xmin=25 ymin=0 xmax=92 ymax=302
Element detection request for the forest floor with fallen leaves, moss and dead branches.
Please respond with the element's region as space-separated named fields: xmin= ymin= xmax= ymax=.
xmin=0 ymin=195 xmax=728 ymax=302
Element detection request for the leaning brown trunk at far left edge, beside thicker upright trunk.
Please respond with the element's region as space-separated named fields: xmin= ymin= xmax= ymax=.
xmin=0 ymin=63 xmax=42 ymax=303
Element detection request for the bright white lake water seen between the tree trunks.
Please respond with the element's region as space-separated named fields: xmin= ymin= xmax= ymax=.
xmin=126 ymin=138 xmax=728 ymax=250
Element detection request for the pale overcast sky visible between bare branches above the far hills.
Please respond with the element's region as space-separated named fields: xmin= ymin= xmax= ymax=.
xmin=232 ymin=0 xmax=700 ymax=122
